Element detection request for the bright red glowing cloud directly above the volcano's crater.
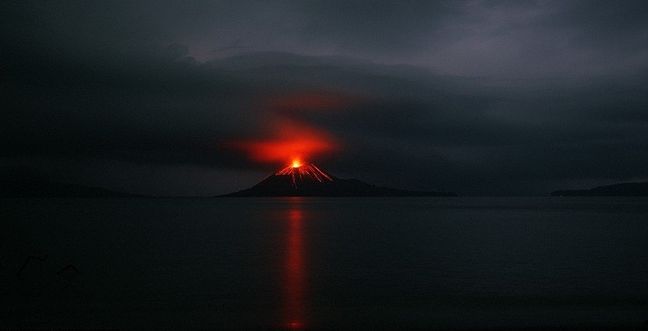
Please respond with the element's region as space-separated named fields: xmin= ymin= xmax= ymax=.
xmin=235 ymin=120 xmax=338 ymax=168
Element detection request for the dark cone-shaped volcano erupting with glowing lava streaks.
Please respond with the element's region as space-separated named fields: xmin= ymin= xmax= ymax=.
xmin=224 ymin=162 xmax=457 ymax=197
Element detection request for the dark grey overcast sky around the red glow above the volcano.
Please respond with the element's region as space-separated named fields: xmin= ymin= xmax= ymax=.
xmin=0 ymin=0 xmax=648 ymax=195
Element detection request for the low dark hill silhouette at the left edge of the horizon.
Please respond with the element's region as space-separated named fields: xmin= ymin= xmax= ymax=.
xmin=0 ymin=168 xmax=137 ymax=198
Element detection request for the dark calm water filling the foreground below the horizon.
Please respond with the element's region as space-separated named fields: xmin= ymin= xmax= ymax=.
xmin=0 ymin=198 xmax=648 ymax=329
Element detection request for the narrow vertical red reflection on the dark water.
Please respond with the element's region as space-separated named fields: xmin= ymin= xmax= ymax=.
xmin=283 ymin=208 xmax=306 ymax=330
